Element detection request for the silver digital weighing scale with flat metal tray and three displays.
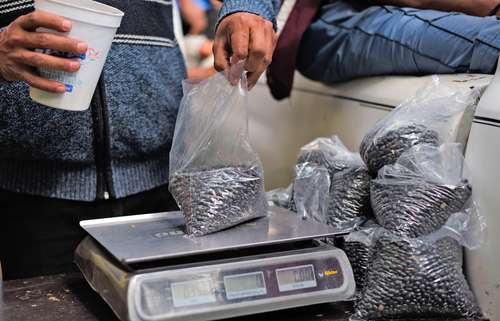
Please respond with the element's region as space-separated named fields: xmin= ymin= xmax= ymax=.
xmin=75 ymin=207 xmax=355 ymax=321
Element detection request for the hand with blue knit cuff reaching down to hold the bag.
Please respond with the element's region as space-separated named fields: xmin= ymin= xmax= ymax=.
xmin=210 ymin=0 xmax=277 ymax=88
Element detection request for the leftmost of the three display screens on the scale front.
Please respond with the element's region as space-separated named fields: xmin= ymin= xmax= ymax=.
xmin=170 ymin=278 xmax=216 ymax=308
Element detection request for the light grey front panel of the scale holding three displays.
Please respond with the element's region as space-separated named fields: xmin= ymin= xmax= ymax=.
xmin=128 ymin=247 xmax=355 ymax=321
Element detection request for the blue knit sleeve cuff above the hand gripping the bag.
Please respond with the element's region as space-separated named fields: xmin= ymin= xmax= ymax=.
xmin=219 ymin=0 xmax=278 ymax=29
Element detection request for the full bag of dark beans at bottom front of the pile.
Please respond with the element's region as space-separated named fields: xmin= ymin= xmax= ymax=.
xmin=352 ymin=229 xmax=481 ymax=320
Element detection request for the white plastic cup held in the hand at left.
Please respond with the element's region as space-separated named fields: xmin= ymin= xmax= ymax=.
xmin=30 ymin=0 xmax=124 ymax=111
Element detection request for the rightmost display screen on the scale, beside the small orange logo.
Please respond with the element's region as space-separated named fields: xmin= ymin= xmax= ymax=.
xmin=276 ymin=265 xmax=317 ymax=292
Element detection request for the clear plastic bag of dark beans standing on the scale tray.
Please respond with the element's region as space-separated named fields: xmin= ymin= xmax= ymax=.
xmin=169 ymin=63 xmax=267 ymax=236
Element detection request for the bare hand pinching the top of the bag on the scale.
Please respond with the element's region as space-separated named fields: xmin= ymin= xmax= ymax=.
xmin=213 ymin=12 xmax=276 ymax=89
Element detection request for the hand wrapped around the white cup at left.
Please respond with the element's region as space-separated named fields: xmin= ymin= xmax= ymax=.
xmin=0 ymin=11 xmax=87 ymax=93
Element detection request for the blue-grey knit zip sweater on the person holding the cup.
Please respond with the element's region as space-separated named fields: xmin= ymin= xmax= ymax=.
xmin=0 ymin=0 xmax=275 ymax=201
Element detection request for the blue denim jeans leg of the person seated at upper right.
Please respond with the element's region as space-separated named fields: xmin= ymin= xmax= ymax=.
xmin=297 ymin=0 xmax=500 ymax=83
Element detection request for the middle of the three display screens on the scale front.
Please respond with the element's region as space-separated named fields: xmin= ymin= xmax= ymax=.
xmin=224 ymin=272 xmax=267 ymax=300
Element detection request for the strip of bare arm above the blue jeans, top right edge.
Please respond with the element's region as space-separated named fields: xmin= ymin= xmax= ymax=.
xmin=377 ymin=0 xmax=500 ymax=17
